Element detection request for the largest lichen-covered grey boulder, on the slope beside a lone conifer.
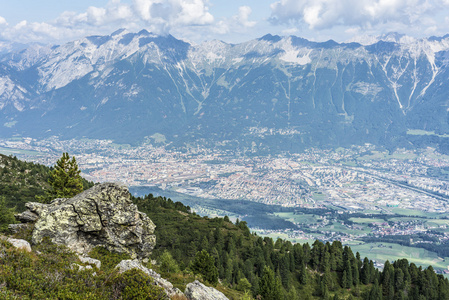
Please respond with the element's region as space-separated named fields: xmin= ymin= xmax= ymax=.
xmin=17 ymin=183 xmax=156 ymax=258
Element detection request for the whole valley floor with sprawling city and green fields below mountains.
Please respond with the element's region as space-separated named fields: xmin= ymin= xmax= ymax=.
xmin=0 ymin=137 xmax=449 ymax=272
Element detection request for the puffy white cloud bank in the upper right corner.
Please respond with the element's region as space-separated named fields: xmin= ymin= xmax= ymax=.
xmin=270 ymin=0 xmax=449 ymax=29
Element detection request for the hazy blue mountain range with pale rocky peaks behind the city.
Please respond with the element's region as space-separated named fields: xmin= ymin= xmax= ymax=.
xmin=0 ymin=30 xmax=449 ymax=152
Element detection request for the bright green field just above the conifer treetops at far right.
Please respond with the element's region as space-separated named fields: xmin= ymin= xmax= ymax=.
xmin=351 ymin=243 xmax=449 ymax=269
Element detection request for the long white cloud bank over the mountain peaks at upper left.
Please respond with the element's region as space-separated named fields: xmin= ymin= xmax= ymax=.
xmin=0 ymin=0 xmax=215 ymax=42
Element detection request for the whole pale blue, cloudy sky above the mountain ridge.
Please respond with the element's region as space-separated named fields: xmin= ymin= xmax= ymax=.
xmin=0 ymin=0 xmax=449 ymax=44
